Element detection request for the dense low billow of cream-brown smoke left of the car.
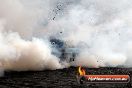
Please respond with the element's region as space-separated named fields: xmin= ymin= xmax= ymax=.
xmin=0 ymin=24 xmax=62 ymax=71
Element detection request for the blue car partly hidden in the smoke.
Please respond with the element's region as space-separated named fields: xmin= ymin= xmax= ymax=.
xmin=50 ymin=38 xmax=79 ymax=62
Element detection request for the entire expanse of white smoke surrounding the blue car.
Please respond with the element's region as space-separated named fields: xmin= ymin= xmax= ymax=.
xmin=0 ymin=0 xmax=132 ymax=74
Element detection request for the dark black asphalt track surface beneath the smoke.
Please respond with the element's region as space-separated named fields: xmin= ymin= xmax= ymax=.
xmin=0 ymin=67 xmax=132 ymax=88
